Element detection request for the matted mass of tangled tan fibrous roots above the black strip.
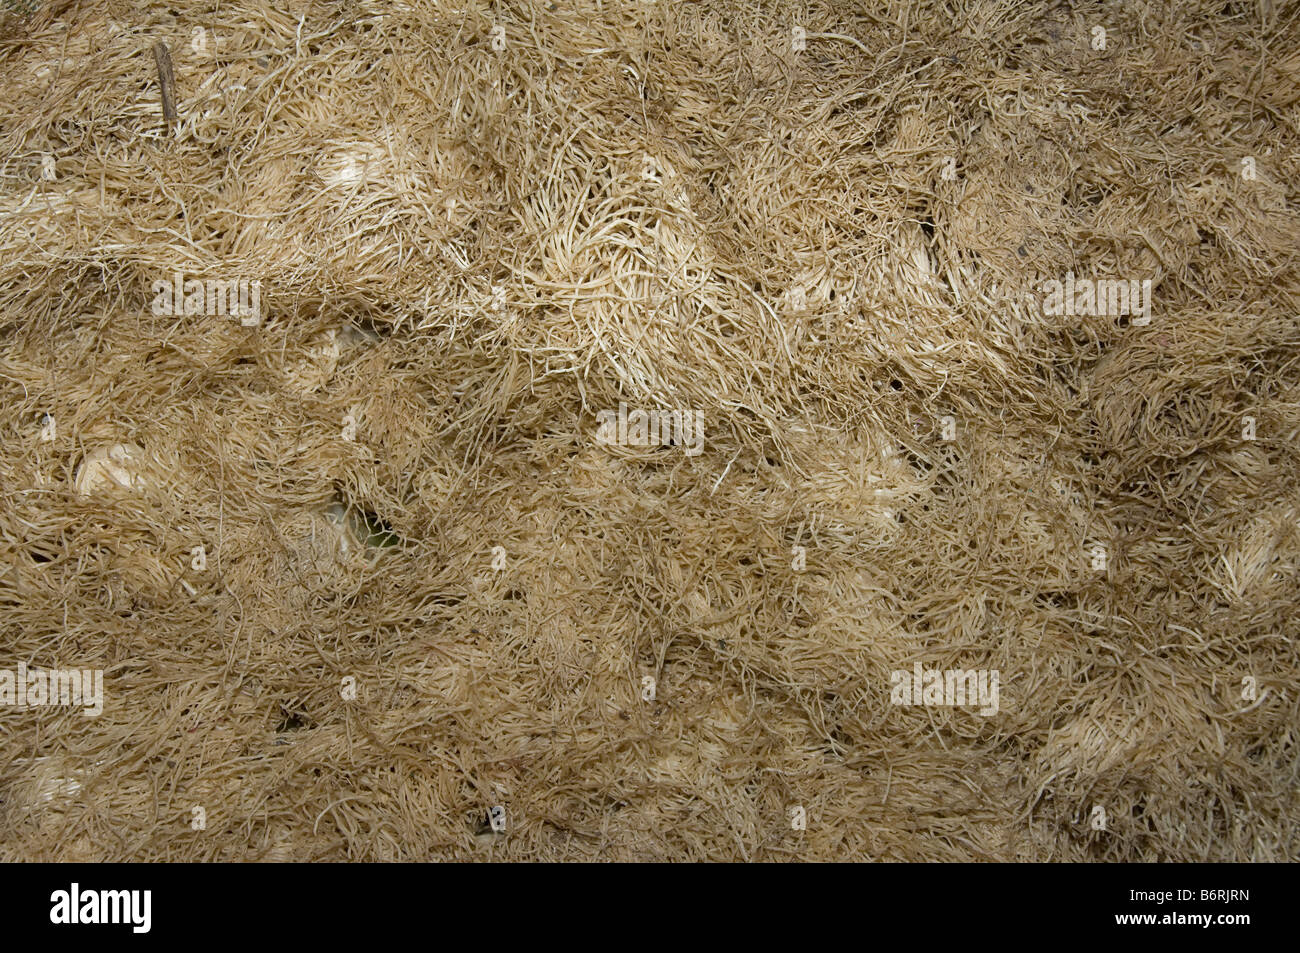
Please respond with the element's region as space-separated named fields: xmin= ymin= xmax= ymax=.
xmin=0 ymin=0 xmax=1300 ymax=861
